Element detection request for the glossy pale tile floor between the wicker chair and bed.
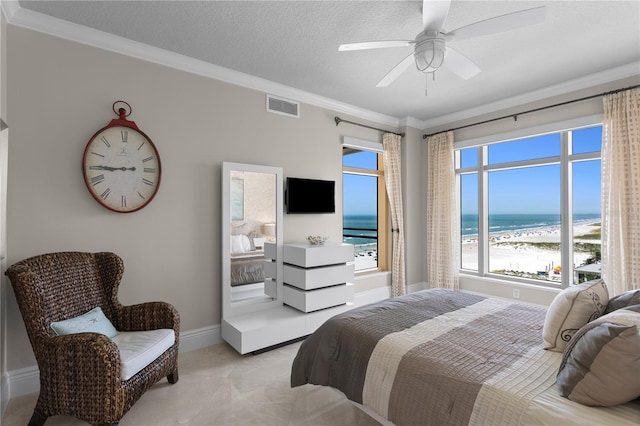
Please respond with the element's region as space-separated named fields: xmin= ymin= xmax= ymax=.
xmin=1 ymin=343 xmax=378 ymax=426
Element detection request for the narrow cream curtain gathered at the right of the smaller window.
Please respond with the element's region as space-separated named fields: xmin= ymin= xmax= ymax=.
xmin=382 ymin=133 xmax=407 ymax=297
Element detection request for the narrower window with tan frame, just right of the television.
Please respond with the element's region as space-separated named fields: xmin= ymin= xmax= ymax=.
xmin=342 ymin=146 xmax=388 ymax=272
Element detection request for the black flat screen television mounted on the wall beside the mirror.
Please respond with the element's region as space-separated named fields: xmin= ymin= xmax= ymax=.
xmin=284 ymin=177 xmax=336 ymax=213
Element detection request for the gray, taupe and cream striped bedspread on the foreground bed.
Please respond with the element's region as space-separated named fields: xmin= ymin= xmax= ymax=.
xmin=291 ymin=289 xmax=640 ymax=425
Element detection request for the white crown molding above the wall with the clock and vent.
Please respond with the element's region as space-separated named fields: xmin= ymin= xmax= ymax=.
xmin=1 ymin=0 xmax=400 ymax=128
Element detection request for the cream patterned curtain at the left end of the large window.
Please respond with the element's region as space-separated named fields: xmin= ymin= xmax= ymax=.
xmin=427 ymin=132 xmax=460 ymax=290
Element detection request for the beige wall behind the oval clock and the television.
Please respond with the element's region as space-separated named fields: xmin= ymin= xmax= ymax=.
xmin=7 ymin=25 xmax=421 ymax=370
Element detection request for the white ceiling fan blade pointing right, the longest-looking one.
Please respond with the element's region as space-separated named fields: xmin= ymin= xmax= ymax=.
xmin=446 ymin=6 xmax=547 ymax=41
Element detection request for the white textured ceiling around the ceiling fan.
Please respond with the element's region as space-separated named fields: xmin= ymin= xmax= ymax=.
xmin=13 ymin=0 xmax=640 ymax=125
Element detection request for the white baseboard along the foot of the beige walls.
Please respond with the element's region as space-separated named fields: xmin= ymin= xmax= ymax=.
xmin=6 ymin=283 xmax=424 ymax=400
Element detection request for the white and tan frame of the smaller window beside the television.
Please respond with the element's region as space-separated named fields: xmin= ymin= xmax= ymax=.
xmin=341 ymin=142 xmax=390 ymax=275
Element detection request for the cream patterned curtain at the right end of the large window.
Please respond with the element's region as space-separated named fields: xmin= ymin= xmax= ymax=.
xmin=602 ymin=89 xmax=640 ymax=295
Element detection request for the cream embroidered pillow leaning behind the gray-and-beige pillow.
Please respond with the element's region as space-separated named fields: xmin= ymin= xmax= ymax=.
xmin=542 ymin=279 xmax=609 ymax=352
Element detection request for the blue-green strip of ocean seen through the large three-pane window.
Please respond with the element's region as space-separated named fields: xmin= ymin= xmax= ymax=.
xmin=462 ymin=213 xmax=600 ymax=236
